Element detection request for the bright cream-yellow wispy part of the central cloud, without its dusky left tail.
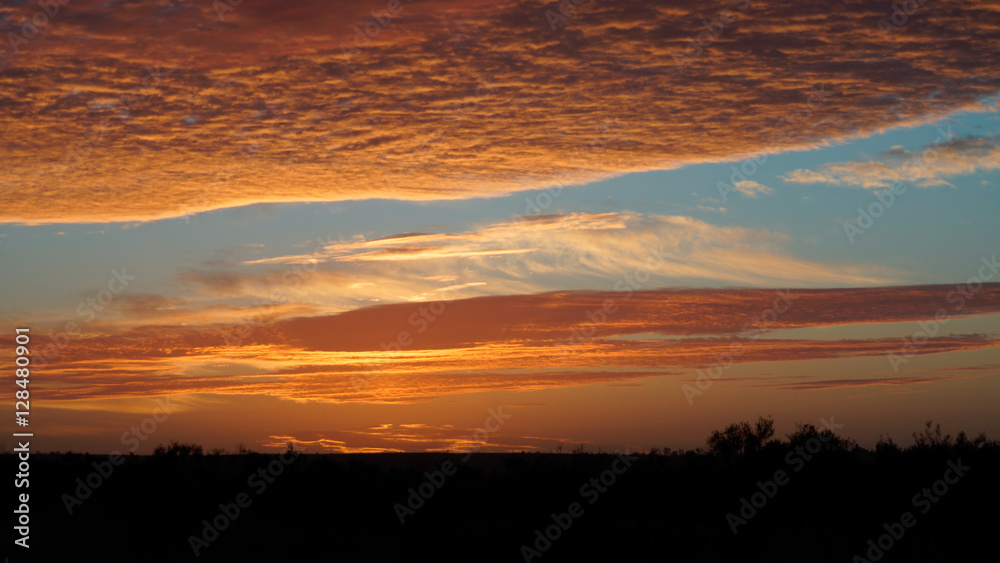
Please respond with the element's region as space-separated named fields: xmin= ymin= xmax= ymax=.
xmin=236 ymin=212 xmax=899 ymax=293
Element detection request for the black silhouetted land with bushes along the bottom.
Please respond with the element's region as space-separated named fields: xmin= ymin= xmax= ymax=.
xmin=2 ymin=420 xmax=1000 ymax=563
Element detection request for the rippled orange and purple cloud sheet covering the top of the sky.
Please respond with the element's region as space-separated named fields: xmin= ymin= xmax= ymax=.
xmin=0 ymin=0 xmax=1000 ymax=223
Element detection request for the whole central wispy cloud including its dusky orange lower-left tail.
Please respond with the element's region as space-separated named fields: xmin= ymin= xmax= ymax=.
xmin=113 ymin=212 xmax=905 ymax=326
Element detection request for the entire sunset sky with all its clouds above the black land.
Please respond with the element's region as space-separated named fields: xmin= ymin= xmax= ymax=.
xmin=0 ymin=0 xmax=1000 ymax=454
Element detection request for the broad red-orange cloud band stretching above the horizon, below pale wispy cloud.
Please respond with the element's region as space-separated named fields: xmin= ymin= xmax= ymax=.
xmin=9 ymin=284 xmax=1000 ymax=403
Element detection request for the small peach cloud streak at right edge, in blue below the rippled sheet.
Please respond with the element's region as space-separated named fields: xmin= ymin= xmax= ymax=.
xmin=782 ymin=137 xmax=1000 ymax=189
